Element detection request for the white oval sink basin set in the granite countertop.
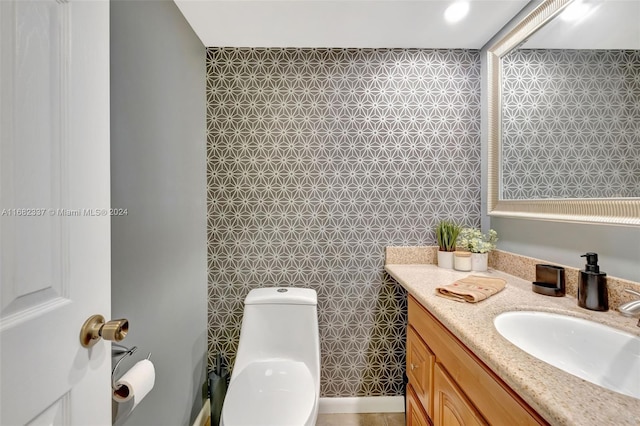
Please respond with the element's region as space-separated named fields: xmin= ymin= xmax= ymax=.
xmin=493 ymin=311 xmax=640 ymax=399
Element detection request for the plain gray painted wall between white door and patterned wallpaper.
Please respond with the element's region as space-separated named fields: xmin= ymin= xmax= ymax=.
xmin=111 ymin=1 xmax=207 ymax=426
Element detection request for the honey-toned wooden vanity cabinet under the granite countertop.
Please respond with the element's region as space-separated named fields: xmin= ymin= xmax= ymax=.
xmin=407 ymin=296 xmax=548 ymax=426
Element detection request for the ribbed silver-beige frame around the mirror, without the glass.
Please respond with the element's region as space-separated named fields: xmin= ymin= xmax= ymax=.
xmin=486 ymin=0 xmax=640 ymax=226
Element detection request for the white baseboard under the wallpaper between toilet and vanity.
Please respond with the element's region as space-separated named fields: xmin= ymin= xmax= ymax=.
xmin=318 ymin=396 xmax=404 ymax=414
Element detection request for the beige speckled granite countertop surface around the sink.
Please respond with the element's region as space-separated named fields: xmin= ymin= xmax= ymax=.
xmin=385 ymin=264 xmax=640 ymax=426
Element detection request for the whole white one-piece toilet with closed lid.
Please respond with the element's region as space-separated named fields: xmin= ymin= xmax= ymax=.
xmin=221 ymin=287 xmax=320 ymax=426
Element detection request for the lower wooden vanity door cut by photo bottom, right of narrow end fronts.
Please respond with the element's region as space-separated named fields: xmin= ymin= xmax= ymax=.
xmin=433 ymin=363 xmax=487 ymax=426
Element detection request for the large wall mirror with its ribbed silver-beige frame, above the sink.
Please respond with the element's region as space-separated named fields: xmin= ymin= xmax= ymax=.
xmin=487 ymin=0 xmax=640 ymax=226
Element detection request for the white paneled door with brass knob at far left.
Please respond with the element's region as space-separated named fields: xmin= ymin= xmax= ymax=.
xmin=0 ymin=0 xmax=111 ymax=426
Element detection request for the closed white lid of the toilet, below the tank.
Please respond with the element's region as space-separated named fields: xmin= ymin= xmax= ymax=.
xmin=222 ymin=361 xmax=316 ymax=426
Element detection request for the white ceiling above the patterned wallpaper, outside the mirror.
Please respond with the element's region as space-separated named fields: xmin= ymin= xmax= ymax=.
xmin=174 ymin=0 xmax=529 ymax=49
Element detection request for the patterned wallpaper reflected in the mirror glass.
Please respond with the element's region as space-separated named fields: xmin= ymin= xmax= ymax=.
xmin=502 ymin=49 xmax=640 ymax=199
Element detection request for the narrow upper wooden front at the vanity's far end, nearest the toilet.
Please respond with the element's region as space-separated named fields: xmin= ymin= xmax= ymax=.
xmin=407 ymin=326 xmax=435 ymax=417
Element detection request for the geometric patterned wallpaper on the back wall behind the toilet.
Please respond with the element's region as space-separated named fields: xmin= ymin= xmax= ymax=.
xmin=207 ymin=48 xmax=481 ymax=397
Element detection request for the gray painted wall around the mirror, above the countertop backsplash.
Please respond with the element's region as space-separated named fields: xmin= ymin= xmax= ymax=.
xmin=482 ymin=0 xmax=640 ymax=281
